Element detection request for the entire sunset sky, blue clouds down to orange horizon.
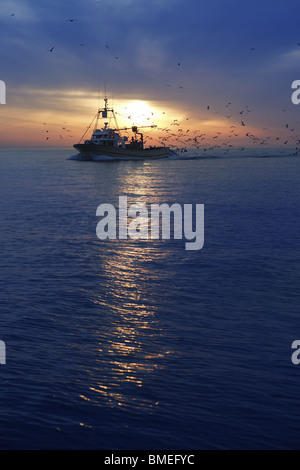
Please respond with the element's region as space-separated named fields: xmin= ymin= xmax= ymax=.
xmin=0 ymin=0 xmax=300 ymax=147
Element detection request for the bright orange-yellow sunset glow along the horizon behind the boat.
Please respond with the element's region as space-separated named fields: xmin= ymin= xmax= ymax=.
xmin=0 ymin=86 xmax=292 ymax=148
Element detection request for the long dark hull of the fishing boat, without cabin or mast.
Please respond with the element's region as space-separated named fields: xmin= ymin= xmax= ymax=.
xmin=74 ymin=144 xmax=170 ymax=160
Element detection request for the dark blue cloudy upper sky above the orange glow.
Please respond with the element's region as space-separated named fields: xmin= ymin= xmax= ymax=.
xmin=0 ymin=0 xmax=300 ymax=145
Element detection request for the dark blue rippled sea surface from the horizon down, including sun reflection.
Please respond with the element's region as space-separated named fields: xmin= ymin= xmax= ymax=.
xmin=0 ymin=149 xmax=300 ymax=450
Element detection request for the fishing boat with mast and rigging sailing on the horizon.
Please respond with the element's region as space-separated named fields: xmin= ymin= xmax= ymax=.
xmin=74 ymin=97 xmax=170 ymax=160
